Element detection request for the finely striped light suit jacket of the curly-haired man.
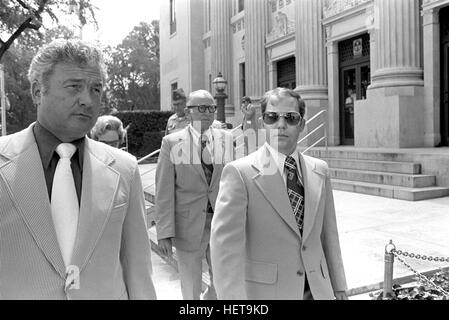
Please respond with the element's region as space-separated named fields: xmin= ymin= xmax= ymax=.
xmin=0 ymin=125 xmax=156 ymax=299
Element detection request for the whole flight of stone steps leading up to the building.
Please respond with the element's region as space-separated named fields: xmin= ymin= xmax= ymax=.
xmin=307 ymin=147 xmax=449 ymax=201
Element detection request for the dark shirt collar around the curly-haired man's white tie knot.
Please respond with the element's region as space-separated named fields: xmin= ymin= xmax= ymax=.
xmin=33 ymin=121 xmax=85 ymax=169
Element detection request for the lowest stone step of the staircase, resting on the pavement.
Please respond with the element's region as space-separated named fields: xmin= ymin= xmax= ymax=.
xmin=331 ymin=179 xmax=449 ymax=201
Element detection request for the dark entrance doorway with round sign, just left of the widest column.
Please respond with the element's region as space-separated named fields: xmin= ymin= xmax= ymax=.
xmin=338 ymin=34 xmax=371 ymax=145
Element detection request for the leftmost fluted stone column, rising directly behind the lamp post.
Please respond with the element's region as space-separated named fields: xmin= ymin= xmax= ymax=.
xmin=210 ymin=0 xmax=234 ymax=116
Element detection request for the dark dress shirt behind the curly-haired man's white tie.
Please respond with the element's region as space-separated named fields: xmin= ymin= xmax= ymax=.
xmin=33 ymin=122 xmax=84 ymax=203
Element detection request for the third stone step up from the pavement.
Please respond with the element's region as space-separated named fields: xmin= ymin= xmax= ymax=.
xmin=323 ymin=158 xmax=421 ymax=174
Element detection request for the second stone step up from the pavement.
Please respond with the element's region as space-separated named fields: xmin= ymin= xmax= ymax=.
xmin=329 ymin=168 xmax=436 ymax=188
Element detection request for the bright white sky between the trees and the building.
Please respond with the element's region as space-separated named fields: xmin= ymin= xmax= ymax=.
xmin=82 ymin=0 xmax=162 ymax=46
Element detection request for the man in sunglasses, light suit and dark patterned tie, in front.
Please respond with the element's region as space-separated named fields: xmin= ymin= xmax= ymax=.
xmin=211 ymin=88 xmax=347 ymax=300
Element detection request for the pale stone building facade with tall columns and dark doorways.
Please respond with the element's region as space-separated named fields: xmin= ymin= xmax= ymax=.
xmin=160 ymin=0 xmax=449 ymax=148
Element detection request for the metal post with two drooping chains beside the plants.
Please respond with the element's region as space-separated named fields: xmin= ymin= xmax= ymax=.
xmin=384 ymin=240 xmax=449 ymax=299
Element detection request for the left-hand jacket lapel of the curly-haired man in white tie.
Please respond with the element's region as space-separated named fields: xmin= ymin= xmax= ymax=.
xmin=0 ymin=125 xmax=65 ymax=278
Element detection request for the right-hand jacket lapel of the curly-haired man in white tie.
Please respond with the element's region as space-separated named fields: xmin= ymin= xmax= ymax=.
xmin=72 ymin=138 xmax=120 ymax=271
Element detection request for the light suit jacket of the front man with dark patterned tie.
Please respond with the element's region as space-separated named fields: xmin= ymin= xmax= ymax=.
xmin=210 ymin=146 xmax=346 ymax=300
